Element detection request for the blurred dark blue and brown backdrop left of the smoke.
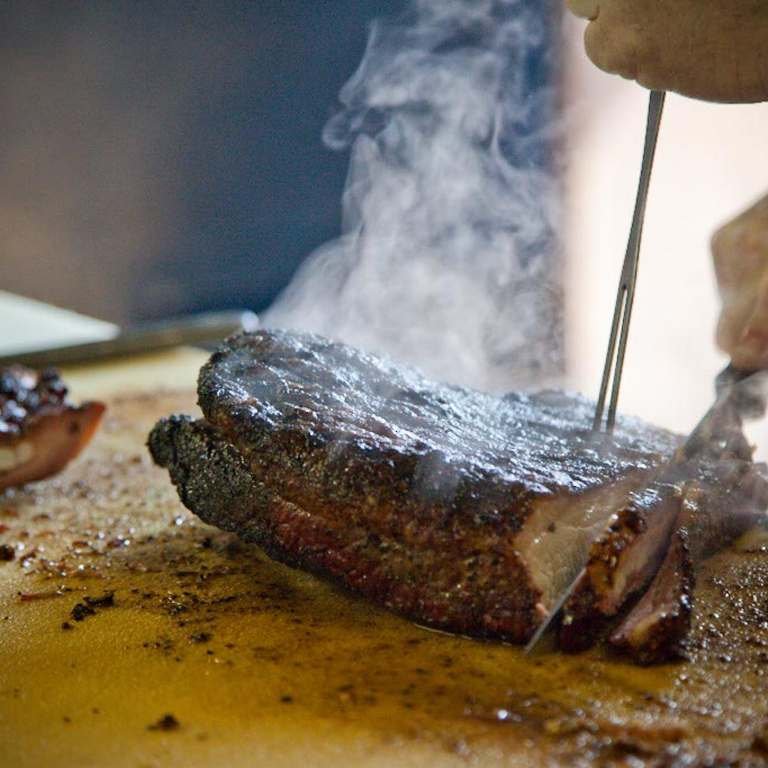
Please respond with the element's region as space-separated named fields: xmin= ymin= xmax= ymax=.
xmin=0 ymin=0 xmax=552 ymax=322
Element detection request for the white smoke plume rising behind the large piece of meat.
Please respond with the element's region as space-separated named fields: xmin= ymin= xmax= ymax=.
xmin=264 ymin=0 xmax=562 ymax=390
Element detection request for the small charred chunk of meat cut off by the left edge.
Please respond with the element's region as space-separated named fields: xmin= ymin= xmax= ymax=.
xmin=0 ymin=365 xmax=105 ymax=491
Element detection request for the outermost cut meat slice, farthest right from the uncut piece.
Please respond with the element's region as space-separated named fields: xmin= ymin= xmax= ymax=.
xmin=610 ymin=461 xmax=768 ymax=664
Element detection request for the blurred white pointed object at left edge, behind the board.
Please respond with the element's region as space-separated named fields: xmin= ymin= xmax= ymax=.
xmin=0 ymin=291 xmax=118 ymax=354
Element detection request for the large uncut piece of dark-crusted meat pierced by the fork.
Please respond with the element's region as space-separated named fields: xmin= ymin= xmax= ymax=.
xmin=149 ymin=331 xmax=678 ymax=642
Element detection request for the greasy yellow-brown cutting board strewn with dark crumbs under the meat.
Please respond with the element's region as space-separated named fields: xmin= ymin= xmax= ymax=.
xmin=0 ymin=350 xmax=768 ymax=768
